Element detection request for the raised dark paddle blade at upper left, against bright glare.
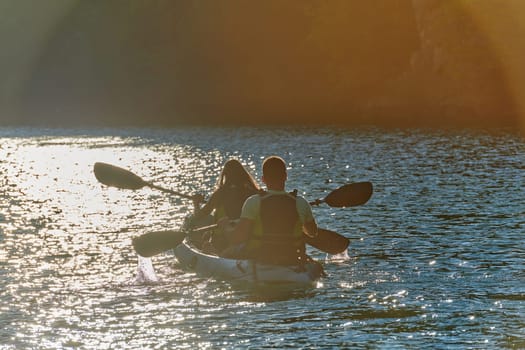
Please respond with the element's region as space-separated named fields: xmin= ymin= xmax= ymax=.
xmin=93 ymin=162 xmax=147 ymax=190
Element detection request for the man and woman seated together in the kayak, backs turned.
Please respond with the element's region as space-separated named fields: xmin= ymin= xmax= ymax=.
xmin=192 ymin=156 xmax=317 ymax=265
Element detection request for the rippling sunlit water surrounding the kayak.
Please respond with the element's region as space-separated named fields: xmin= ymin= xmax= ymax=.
xmin=0 ymin=128 xmax=525 ymax=349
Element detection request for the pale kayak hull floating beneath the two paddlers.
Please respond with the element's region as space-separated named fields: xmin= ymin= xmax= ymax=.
xmin=174 ymin=238 xmax=324 ymax=285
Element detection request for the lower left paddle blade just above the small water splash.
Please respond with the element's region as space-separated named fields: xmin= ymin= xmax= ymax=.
xmin=133 ymin=231 xmax=186 ymax=258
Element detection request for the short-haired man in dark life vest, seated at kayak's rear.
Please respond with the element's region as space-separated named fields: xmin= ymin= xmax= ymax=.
xmin=222 ymin=156 xmax=317 ymax=265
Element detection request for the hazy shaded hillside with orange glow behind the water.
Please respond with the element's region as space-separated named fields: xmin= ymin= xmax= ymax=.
xmin=0 ymin=0 xmax=525 ymax=129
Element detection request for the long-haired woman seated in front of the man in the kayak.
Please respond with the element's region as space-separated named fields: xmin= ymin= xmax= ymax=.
xmin=191 ymin=159 xmax=260 ymax=251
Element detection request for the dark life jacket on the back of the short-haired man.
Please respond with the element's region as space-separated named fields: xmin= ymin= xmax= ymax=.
xmin=248 ymin=191 xmax=306 ymax=265
